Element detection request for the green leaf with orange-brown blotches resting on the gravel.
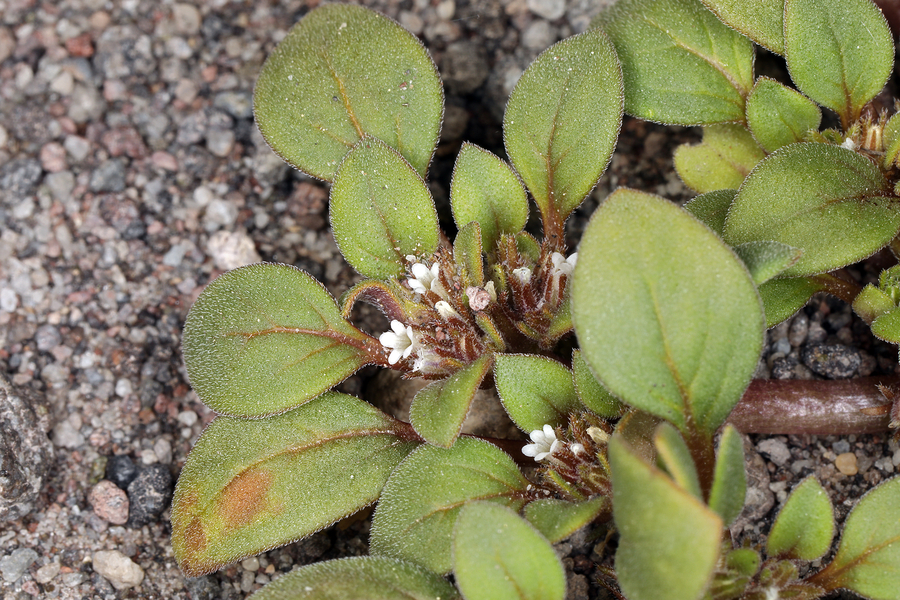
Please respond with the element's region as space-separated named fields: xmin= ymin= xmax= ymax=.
xmin=172 ymin=392 xmax=416 ymax=577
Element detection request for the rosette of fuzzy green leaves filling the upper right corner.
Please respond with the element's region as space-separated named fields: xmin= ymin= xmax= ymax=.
xmin=595 ymin=0 xmax=900 ymax=326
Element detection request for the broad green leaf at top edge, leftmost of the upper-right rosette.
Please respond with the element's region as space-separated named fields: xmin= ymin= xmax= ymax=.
xmin=597 ymin=0 xmax=753 ymax=125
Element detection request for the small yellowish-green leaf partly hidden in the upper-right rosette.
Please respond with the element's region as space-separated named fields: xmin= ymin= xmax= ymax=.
xmin=675 ymin=124 xmax=766 ymax=193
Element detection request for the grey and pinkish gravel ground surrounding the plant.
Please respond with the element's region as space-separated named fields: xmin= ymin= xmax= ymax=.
xmin=0 ymin=0 xmax=900 ymax=600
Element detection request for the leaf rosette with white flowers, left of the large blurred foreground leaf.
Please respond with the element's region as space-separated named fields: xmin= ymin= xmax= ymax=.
xmin=172 ymin=5 xmax=622 ymax=599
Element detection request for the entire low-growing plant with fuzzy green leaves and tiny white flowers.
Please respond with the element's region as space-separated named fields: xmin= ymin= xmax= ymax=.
xmin=172 ymin=0 xmax=900 ymax=600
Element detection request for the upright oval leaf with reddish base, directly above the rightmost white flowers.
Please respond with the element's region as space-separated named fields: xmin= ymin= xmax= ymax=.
xmin=503 ymin=25 xmax=622 ymax=233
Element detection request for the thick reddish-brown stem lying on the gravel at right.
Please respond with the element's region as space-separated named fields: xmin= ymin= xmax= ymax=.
xmin=728 ymin=375 xmax=900 ymax=435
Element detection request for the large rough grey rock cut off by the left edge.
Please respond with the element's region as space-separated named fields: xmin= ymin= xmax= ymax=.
xmin=0 ymin=376 xmax=53 ymax=522
